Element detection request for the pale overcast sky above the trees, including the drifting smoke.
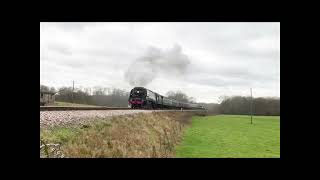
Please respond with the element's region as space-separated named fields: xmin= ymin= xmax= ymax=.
xmin=40 ymin=22 xmax=280 ymax=103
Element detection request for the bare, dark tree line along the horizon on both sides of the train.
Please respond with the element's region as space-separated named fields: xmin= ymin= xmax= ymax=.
xmin=40 ymin=85 xmax=280 ymax=116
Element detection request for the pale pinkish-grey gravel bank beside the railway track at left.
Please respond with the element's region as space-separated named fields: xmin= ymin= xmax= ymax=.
xmin=40 ymin=110 xmax=152 ymax=128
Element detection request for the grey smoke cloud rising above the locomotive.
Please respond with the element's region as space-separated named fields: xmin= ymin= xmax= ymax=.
xmin=124 ymin=45 xmax=190 ymax=86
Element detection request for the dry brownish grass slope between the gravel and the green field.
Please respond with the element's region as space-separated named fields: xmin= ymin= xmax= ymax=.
xmin=41 ymin=112 xmax=194 ymax=158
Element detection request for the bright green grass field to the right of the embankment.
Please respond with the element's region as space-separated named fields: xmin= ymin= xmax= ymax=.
xmin=176 ymin=115 xmax=280 ymax=158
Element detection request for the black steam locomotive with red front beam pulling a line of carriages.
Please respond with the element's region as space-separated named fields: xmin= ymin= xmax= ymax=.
xmin=129 ymin=87 xmax=204 ymax=110
